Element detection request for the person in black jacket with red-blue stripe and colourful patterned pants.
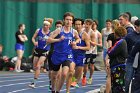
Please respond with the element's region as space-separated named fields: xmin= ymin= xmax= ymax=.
xmin=108 ymin=27 xmax=127 ymax=93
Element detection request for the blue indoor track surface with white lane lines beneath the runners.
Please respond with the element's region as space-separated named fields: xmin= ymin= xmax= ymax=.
xmin=0 ymin=71 xmax=106 ymax=93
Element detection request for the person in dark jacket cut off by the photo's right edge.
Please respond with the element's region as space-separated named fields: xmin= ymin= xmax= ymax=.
xmin=126 ymin=19 xmax=140 ymax=93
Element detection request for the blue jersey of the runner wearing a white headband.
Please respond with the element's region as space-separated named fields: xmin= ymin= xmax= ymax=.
xmin=36 ymin=28 xmax=50 ymax=50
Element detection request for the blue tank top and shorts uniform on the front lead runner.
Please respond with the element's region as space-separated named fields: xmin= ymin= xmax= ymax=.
xmin=52 ymin=27 xmax=74 ymax=66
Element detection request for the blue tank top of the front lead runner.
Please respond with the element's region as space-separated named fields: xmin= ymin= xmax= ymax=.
xmin=54 ymin=27 xmax=74 ymax=54
